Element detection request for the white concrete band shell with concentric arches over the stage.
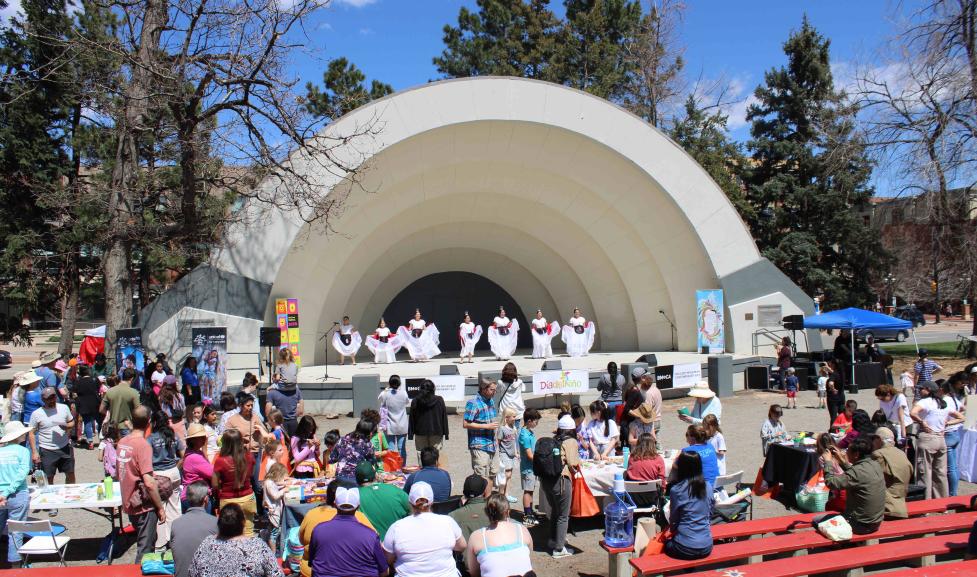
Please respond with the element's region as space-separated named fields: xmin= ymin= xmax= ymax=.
xmin=147 ymin=78 xmax=809 ymax=364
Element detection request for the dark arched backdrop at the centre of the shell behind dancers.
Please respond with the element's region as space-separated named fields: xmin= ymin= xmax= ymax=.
xmin=384 ymin=271 xmax=532 ymax=351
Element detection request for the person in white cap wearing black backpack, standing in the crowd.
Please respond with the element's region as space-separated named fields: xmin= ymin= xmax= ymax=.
xmin=533 ymin=415 xmax=580 ymax=559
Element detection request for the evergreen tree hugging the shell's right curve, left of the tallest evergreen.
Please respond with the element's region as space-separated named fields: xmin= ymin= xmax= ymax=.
xmin=669 ymin=96 xmax=752 ymax=220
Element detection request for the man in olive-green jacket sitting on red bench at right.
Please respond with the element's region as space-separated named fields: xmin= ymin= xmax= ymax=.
xmin=824 ymin=436 xmax=885 ymax=535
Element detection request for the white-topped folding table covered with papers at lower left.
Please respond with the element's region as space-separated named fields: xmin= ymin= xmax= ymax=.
xmin=30 ymin=481 xmax=122 ymax=565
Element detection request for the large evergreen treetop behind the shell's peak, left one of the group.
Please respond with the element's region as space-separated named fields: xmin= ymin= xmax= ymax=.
xmin=434 ymin=0 xmax=560 ymax=81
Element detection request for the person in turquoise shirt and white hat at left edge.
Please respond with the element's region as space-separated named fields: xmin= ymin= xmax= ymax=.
xmin=0 ymin=421 xmax=31 ymax=567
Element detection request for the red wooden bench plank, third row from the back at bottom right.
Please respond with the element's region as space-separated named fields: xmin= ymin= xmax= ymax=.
xmin=686 ymin=534 xmax=967 ymax=577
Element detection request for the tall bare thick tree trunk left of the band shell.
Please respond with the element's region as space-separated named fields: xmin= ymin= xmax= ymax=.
xmin=102 ymin=0 xmax=167 ymax=368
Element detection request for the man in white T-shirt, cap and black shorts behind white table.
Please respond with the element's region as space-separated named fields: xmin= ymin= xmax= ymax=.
xmin=29 ymin=387 xmax=75 ymax=488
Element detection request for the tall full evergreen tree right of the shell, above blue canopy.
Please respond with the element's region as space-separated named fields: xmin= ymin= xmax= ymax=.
xmin=744 ymin=17 xmax=887 ymax=307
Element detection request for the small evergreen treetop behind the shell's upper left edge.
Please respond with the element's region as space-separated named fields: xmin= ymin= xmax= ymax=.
xmin=305 ymin=58 xmax=393 ymax=119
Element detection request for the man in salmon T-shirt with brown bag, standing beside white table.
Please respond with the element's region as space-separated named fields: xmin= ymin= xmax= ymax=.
xmin=118 ymin=405 xmax=166 ymax=564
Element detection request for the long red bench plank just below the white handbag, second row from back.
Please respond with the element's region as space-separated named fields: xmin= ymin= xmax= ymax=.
xmin=631 ymin=512 xmax=977 ymax=575
